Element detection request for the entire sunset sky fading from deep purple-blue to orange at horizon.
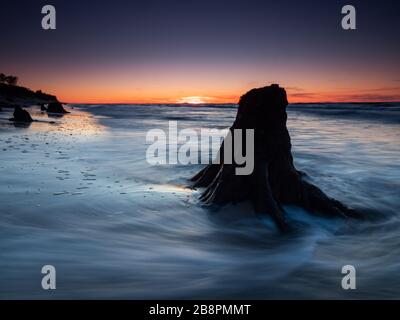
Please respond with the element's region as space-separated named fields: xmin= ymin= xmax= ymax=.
xmin=0 ymin=0 xmax=400 ymax=103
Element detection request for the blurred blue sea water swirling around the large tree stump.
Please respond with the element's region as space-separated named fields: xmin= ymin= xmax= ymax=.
xmin=0 ymin=104 xmax=400 ymax=299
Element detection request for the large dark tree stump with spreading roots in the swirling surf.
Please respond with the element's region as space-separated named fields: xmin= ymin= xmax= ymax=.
xmin=191 ymin=85 xmax=360 ymax=230
